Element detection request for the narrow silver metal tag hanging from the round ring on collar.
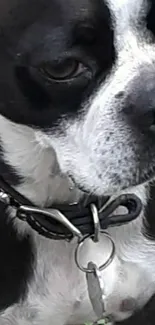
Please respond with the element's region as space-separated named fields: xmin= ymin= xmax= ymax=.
xmin=86 ymin=262 xmax=105 ymax=319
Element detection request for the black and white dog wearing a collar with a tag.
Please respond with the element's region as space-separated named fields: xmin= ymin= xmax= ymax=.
xmin=0 ymin=0 xmax=155 ymax=325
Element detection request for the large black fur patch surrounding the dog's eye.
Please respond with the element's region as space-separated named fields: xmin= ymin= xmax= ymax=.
xmin=0 ymin=0 xmax=115 ymax=128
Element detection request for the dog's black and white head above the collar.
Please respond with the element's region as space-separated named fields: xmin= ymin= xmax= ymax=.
xmin=0 ymin=0 xmax=155 ymax=202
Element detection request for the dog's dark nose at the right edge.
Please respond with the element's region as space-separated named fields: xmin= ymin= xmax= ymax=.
xmin=124 ymin=70 xmax=155 ymax=131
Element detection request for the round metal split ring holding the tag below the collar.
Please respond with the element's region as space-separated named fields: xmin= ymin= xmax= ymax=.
xmin=75 ymin=230 xmax=115 ymax=273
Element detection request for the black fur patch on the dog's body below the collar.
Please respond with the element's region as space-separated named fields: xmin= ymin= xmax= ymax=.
xmin=0 ymin=203 xmax=34 ymax=310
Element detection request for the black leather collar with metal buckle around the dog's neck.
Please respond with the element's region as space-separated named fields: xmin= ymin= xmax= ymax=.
xmin=0 ymin=177 xmax=142 ymax=240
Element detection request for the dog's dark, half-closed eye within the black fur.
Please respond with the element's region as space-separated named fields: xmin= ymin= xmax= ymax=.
xmin=39 ymin=59 xmax=84 ymax=82
